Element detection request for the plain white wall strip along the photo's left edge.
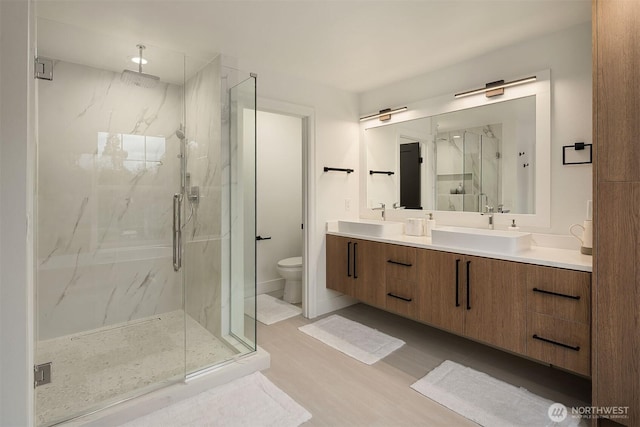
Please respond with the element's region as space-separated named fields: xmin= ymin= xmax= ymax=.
xmin=0 ymin=0 xmax=35 ymax=426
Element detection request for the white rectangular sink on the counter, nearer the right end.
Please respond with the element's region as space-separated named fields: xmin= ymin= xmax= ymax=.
xmin=431 ymin=226 xmax=531 ymax=254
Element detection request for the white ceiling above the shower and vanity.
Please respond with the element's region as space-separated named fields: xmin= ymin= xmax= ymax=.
xmin=37 ymin=0 xmax=591 ymax=93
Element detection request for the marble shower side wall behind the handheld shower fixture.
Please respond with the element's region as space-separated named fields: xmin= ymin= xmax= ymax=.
xmin=185 ymin=58 xmax=229 ymax=336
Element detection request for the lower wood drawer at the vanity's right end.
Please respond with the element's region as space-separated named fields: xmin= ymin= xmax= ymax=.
xmin=526 ymin=311 xmax=591 ymax=376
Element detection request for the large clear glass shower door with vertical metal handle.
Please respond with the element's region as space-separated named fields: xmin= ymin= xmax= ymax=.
xmin=35 ymin=19 xmax=185 ymax=425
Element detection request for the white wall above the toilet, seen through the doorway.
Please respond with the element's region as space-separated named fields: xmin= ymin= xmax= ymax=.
xmin=256 ymin=111 xmax=303 ymax=293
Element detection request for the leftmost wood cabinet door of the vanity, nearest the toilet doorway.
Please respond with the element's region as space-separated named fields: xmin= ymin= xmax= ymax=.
xmin=327 ymin=234 xmax=355 ymax=296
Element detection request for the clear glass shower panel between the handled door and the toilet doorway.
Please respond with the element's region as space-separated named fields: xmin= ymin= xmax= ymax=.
xmin=183 ymin=63 xmax=256 ymax=376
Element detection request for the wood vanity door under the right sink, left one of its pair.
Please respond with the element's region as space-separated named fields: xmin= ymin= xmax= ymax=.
xmin=417 ymin=249 xmax=465 ymax=334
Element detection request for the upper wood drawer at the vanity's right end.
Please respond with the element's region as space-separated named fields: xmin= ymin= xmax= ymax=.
xmin=523 ymin=265 xmax=591 ymax=325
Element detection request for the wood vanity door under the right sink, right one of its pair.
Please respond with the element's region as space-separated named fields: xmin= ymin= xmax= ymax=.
xmin=460 ymin=256 xmax=527 ymax=353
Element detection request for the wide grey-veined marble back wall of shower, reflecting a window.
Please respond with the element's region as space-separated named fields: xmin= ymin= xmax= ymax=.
xmin=37 ymin=61 xmax=185 ymax=340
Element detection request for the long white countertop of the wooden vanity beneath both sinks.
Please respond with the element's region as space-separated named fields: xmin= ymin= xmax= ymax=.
xmin=327 ymin=223 xmax=593 ymax=272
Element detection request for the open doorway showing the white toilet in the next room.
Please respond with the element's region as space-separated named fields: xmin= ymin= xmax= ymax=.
xmin=256 ymin=100 xmax=312 ymax=317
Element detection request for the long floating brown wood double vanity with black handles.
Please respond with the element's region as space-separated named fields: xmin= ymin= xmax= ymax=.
xmin=326 ymin=233 xmax=591 ymax=376
